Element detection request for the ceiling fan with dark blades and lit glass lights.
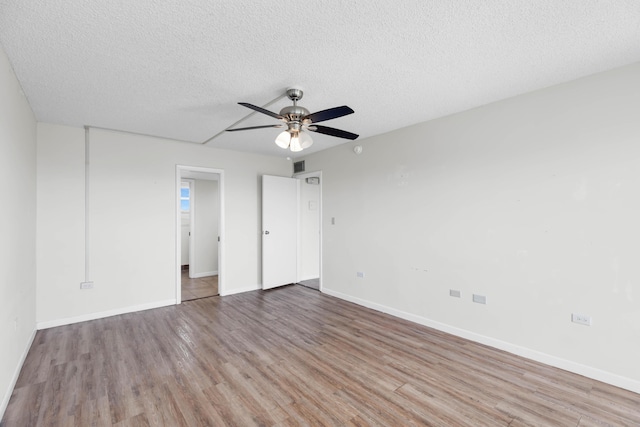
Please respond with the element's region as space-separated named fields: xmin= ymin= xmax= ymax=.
xmin=227 ymin=88 xmax=359 ymax=151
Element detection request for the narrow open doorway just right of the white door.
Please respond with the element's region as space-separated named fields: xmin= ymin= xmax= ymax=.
xmin=294 ymin=171 xmax=322 ymax=291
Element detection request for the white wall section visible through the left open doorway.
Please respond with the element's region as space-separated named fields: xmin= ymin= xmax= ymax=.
xmin=192 ymin=179 xmax=220 ymax=277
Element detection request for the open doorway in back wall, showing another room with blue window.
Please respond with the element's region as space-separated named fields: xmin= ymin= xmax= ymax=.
xmin=176 ymin=166 xmax=224 ymax=303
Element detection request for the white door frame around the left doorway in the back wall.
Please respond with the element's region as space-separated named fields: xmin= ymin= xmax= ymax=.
xmin=174 ymin=165 xmax=226 ymax=304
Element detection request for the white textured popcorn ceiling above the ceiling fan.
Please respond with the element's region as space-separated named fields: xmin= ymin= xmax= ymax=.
xmin=0 ymin=0 xmax=640 ymax=156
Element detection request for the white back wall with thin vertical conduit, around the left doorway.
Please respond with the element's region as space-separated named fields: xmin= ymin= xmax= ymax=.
xmin=37 ymin=127 xmax=291 ymax=327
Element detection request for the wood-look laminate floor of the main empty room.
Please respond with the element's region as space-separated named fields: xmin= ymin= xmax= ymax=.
xmin=2 ymin=286 xmax=640 ymax=427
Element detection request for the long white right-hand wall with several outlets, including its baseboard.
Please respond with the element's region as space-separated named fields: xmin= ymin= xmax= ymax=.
xmin=304 ymin=64 xmax=640 ymax=392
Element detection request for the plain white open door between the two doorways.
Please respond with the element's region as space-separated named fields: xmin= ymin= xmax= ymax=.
xmin=262 ymin=175 xmax=298 ymax=289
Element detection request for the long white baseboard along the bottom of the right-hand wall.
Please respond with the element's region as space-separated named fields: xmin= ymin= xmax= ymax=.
xmin=322 ymin=288 xmax=640 ymax=393
